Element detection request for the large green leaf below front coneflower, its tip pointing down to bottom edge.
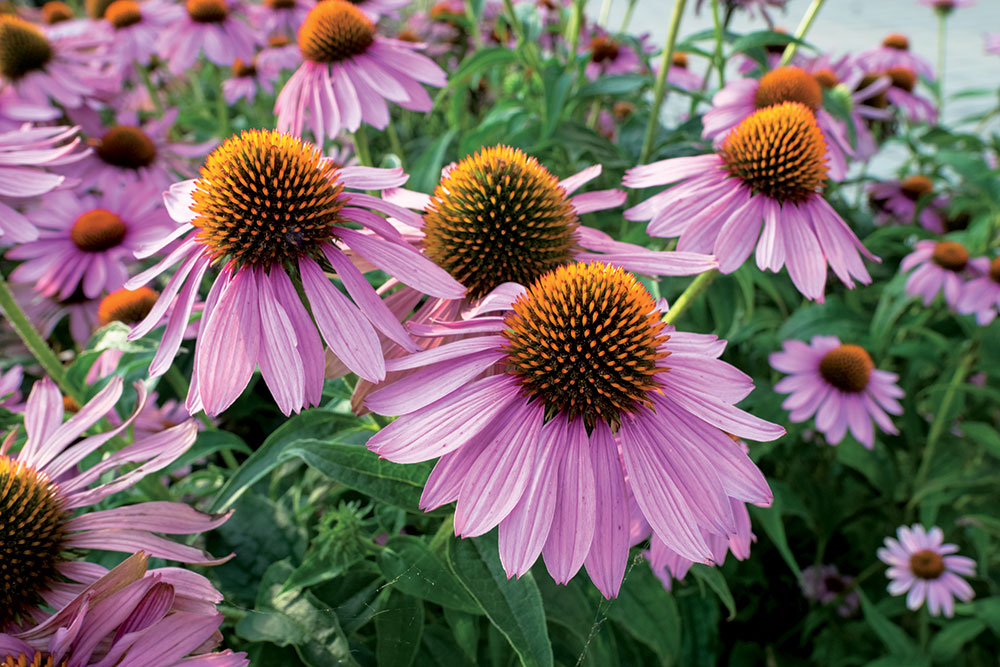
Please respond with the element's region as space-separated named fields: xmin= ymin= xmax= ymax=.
xmin=448 ymin=531 xmax=553 ymax=667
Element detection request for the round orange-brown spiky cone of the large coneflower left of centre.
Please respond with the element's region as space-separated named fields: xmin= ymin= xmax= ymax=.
xmin=191 ymin=130 xmax=343 ymax=268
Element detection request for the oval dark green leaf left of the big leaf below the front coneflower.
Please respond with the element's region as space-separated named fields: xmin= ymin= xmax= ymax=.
xmin=378 ymin=535 xmax=483 ymax=614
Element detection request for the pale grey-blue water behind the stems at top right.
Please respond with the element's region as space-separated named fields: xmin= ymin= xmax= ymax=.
xmin=588 ymin=0 xmax=1000 ymax=128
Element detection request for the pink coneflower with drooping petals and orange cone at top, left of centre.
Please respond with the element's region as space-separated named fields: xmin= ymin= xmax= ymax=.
xmin=274 ymin=0 xmax=447 ymax=144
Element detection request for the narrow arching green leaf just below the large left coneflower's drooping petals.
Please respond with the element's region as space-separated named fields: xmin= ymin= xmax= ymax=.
xmin=212 ymin=409 xmax=358 ymax=512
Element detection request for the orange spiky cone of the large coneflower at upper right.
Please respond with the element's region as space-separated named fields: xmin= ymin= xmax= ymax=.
xmin=720 ymin=102 xmax=827 ymax=203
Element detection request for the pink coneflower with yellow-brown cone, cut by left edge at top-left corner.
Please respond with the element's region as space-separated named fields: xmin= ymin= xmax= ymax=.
xmin=0 ymin=14 xmax=113 ymax=109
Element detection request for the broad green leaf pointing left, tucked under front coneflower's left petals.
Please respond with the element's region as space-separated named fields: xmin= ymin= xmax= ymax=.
xmin=278 ymin=438 xmax=433 ymax=511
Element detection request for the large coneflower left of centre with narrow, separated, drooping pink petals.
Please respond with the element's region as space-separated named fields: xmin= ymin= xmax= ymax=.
xmin=126 ymin=130 xmax=465 ymax=415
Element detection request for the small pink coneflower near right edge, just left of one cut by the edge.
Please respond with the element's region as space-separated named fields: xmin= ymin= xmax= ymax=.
xmin=899 ymin=241 xmax=969 ymax=310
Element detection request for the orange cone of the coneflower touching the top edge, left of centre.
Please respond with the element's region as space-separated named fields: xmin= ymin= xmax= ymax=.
xmin=299 ymin=0 xmax=375 ymax=63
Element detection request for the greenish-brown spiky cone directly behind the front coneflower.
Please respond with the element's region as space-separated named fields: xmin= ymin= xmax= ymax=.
xmin=424 ymin=146 xmax=579 ymax=298
